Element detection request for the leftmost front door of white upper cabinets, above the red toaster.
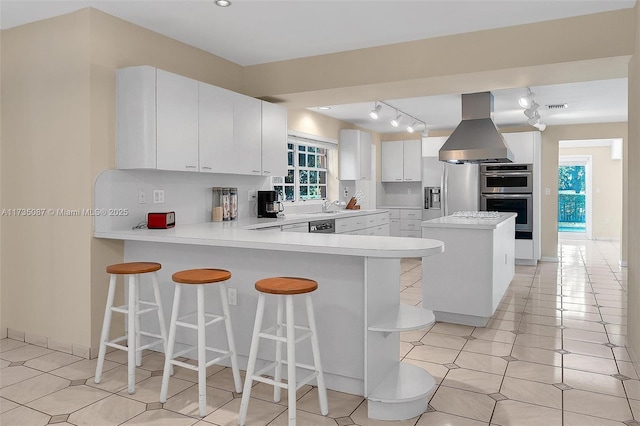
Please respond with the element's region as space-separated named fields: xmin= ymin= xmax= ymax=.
xmin=156 ymin=70 xmax=198 ymax=172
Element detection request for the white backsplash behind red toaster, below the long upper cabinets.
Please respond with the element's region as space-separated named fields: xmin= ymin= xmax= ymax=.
xmin=94 ymin=170 xmax=269 ymax=232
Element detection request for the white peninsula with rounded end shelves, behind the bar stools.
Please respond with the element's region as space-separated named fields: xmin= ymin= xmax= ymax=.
xmin=94 ymin=225 xmax=444 ymax=420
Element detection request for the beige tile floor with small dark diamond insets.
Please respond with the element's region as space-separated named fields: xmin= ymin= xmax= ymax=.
xmin=0 ymin=240 xmax=640 ymax=426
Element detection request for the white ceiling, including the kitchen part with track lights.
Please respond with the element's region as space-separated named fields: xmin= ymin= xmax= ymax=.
xmin=0 ymin=0 xmax=636 ymax=133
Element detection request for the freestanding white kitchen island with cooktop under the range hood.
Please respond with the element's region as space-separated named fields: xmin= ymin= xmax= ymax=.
xmin=422 ymin=213 xmax=517 ymax=327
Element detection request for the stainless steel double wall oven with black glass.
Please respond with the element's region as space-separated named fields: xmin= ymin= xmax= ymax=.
xmin=480 ymin=164 xmax=533 ymax=240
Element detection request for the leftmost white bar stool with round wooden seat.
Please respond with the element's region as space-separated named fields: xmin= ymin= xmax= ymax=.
xmin=94 ymin=262 xmax=167 ymax=394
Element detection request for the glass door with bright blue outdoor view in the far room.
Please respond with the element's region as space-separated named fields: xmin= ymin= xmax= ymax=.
xmin=558 ymin=155 xmax=593 ymax=239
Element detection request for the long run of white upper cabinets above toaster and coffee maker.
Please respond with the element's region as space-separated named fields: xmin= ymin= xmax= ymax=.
xmin=117 ymin=66 xmax=287 ymax=176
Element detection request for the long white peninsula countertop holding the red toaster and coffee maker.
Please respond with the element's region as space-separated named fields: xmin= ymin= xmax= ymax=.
xmin=94 ymin=211 xmax=444 ymax=258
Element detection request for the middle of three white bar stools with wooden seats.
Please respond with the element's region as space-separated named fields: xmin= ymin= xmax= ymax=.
xmin=160 ymin=269 xmax=242 ymax=417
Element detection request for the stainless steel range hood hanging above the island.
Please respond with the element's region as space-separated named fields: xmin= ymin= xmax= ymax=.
xmin=438 ymin=92 xmax=513 ymax=163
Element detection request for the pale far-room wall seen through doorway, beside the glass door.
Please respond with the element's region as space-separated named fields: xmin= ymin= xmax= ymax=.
xmin=556 ymin=146 xmax=622 ymax=240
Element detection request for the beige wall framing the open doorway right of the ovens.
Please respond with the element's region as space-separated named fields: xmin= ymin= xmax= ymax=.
xmin=541 ymin=123 xmax=627 ymax=260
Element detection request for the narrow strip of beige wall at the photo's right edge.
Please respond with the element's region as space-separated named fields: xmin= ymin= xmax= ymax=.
xmin=625 ymin=4 xmax=640 ymax=368
